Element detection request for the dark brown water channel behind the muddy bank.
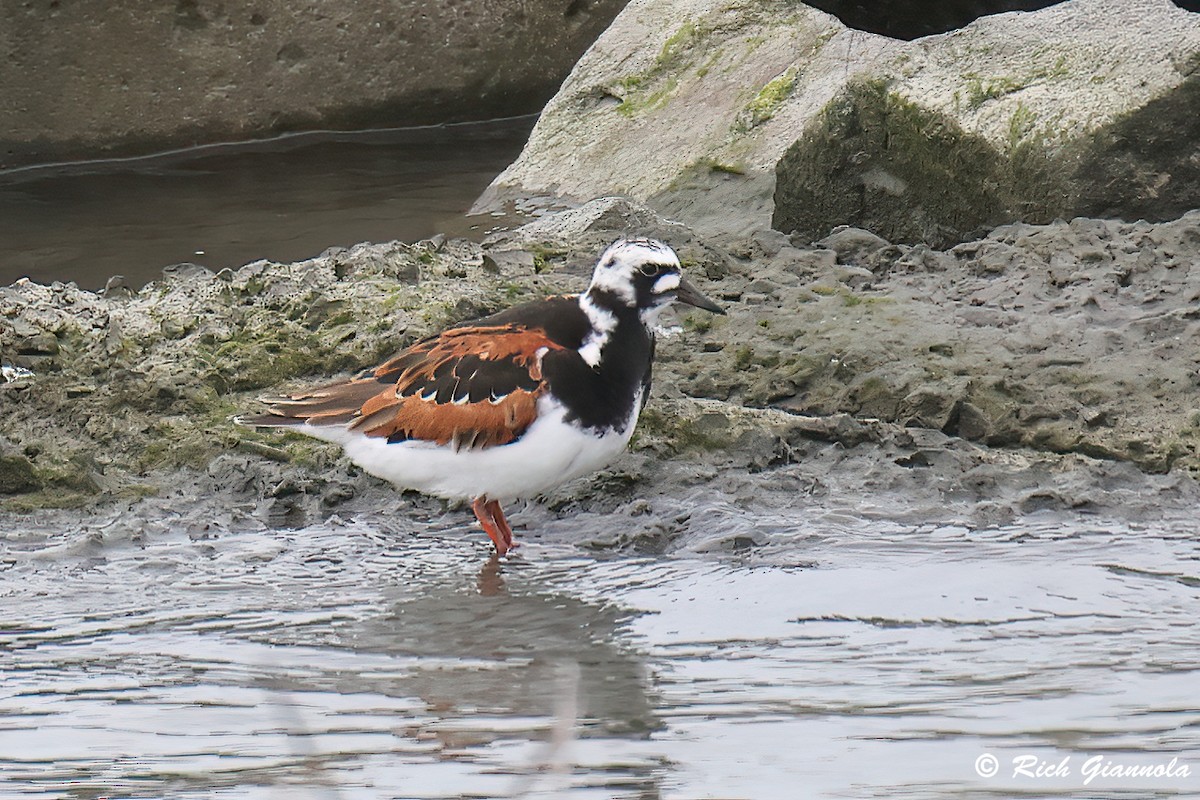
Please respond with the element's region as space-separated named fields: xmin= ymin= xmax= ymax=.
xmin=0 ymin=119 xmax=533 ymax=289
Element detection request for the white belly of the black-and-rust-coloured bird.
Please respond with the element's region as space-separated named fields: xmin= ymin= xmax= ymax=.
xmin=294 ymin=396 xmax=641 ymax=500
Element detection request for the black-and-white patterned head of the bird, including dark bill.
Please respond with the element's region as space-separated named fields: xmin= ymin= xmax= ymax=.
xmin=588 ymin=239 xmax=725 ymax=324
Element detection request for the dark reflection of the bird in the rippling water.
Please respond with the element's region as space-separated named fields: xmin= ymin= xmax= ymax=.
xmin=326 ymin=554 xmax=661 ymax=795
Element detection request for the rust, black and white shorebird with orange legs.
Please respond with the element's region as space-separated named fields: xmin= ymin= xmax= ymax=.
xmin=239 ymin=239 xmax=725 ymax=557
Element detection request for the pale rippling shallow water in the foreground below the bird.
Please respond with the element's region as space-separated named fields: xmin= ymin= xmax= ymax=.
xmin=0 ymin=505 xmax=1200 ymax=799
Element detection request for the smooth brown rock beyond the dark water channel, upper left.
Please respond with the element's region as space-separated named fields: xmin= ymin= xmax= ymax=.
xmin=0 ymin=0 xmax=624 ymax=168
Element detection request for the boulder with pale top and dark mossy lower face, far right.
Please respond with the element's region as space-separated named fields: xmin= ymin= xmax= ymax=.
xmin=773 ymin=0 xmax=1200 ymax=246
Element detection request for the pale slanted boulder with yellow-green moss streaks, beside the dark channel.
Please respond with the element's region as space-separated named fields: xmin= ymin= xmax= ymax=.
xmin=476 ymin=0 xmax=904 ymax=230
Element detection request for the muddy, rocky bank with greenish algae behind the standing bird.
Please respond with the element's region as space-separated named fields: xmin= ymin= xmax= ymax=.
xmin=0 ymin=199 xmax=1200 ymax=548
